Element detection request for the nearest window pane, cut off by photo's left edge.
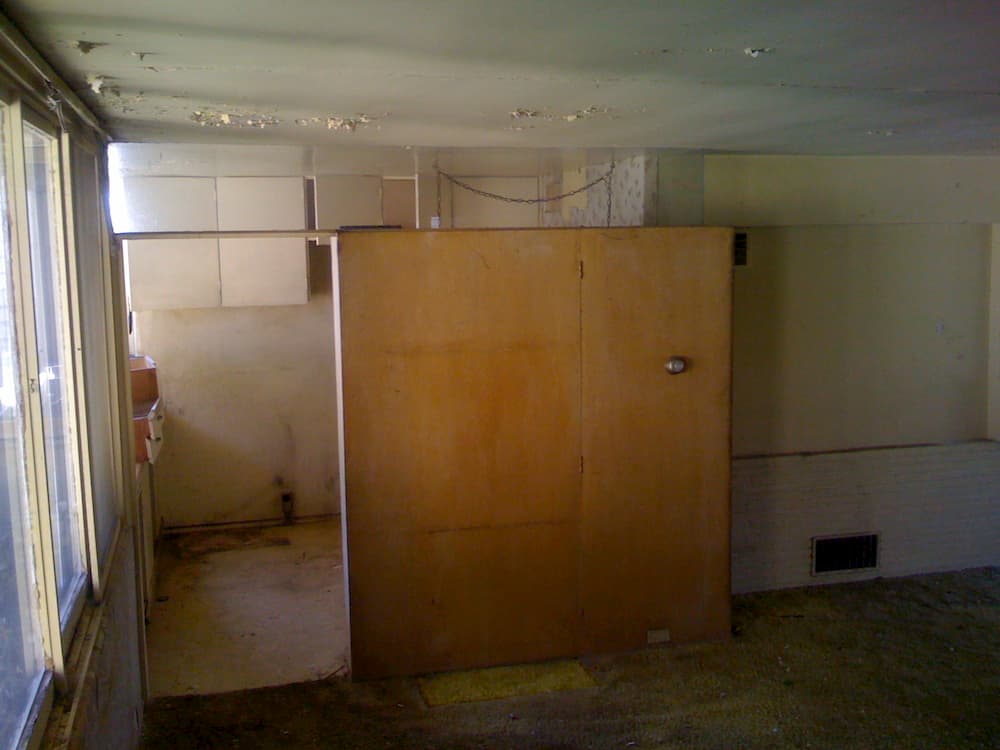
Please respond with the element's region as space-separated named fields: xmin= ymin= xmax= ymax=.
xmin=0 ymin=108 xmax=44 ymax=748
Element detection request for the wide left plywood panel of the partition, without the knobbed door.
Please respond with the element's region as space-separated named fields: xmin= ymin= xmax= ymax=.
xmin=340 ymin=231 xmax=580 ymax=677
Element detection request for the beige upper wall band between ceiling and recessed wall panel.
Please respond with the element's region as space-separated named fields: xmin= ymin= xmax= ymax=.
xmin=705 ymin=156 xmax=1000 ymax=226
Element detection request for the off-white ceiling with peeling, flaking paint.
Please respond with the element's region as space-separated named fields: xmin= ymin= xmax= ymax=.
xmin=5 ymin=0 xmax=1000 ymax=154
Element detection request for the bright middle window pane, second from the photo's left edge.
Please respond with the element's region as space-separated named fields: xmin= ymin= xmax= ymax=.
xmin=24 ymin=125 xmax=84 ymax=624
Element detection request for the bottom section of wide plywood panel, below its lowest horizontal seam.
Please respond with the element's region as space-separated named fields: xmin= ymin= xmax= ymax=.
xmin=349 ymin=522 xmax=579 ymax=679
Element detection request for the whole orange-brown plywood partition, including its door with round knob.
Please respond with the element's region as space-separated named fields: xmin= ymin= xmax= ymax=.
xmin=339 ymin=229 xmax=731 ymax=678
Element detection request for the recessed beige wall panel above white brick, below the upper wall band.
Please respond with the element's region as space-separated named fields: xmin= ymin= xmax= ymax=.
xmin=733 ymin=225 xmax=989 ymax=455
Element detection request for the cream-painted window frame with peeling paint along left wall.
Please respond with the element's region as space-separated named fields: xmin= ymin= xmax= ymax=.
xmin=0 ymin=72 xmax=133 ymax=748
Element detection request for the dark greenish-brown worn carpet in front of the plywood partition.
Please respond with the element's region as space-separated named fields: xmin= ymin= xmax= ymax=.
xmin=143 ymin=568 xmax=1000 ymax=750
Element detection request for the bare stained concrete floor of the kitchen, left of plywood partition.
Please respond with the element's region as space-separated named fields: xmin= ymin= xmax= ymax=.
xmin=148 ymin=519 xmax=347 ymax=697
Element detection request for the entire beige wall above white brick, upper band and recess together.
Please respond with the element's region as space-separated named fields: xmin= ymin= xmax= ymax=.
xmin=704 ymin=156 xmax=1000 ymax=454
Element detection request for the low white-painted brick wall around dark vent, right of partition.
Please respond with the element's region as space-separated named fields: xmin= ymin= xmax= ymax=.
xmin=732 ymin=441 xmax=1000 ymax=593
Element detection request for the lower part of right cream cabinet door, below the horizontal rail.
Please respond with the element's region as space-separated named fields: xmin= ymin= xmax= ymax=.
xmin=219 ymin=237 xmax=309 ymax=307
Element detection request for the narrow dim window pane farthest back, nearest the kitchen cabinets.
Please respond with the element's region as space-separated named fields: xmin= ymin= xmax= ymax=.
xmin=72 ymin=146 xmax=118 ymax=560
